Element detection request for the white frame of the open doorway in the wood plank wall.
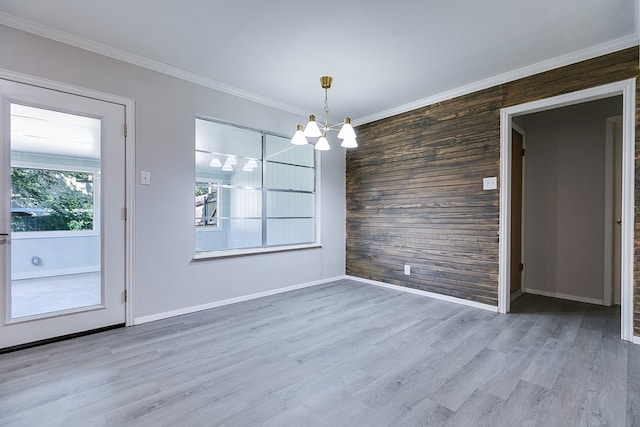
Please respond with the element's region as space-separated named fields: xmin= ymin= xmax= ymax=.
xmin=498 ymin=79 xmax=636 ymax=341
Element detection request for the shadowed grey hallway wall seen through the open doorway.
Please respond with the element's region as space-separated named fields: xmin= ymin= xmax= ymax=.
xmin=516 ymin=97 xmax=622 ymax=302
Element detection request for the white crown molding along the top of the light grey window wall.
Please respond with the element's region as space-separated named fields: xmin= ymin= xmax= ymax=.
xmin=0 ymin=12 xmax=307 ymax=116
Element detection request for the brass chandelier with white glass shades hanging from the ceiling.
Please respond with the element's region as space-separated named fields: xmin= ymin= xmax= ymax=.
xmin=291 ymin=76 xmax=358 ymax=151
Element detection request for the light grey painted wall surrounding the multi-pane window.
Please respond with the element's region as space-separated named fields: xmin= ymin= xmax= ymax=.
xmin=0 ymin=26 xmax=345 ymax=318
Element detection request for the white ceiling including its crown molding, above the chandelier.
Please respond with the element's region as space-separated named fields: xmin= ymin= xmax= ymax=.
xmin=0 ymin=0 xmax=640 ymax=124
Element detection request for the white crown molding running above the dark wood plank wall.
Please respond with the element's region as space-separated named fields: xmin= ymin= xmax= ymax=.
xmin=353 ymin=32 xmax=640 ymax=126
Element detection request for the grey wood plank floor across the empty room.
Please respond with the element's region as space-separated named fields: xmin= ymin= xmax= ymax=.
xmin=0 ymin=280 xmax=640 ymax=427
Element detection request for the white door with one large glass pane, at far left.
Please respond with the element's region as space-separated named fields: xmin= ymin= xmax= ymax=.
xmin=0 ymin=79 xmax=125 ymax=348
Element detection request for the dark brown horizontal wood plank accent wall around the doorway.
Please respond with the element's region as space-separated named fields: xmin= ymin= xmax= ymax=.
xmin=346 ymin=47 xmax=640 ymax=324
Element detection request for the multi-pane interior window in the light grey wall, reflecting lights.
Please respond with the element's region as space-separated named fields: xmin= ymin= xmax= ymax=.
xmin=194 ymin=119 xmax=316 ymax=252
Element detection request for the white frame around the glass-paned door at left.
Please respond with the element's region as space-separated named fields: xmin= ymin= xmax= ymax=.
xmin=0 ymin=68 xmax=135 ymax=326
